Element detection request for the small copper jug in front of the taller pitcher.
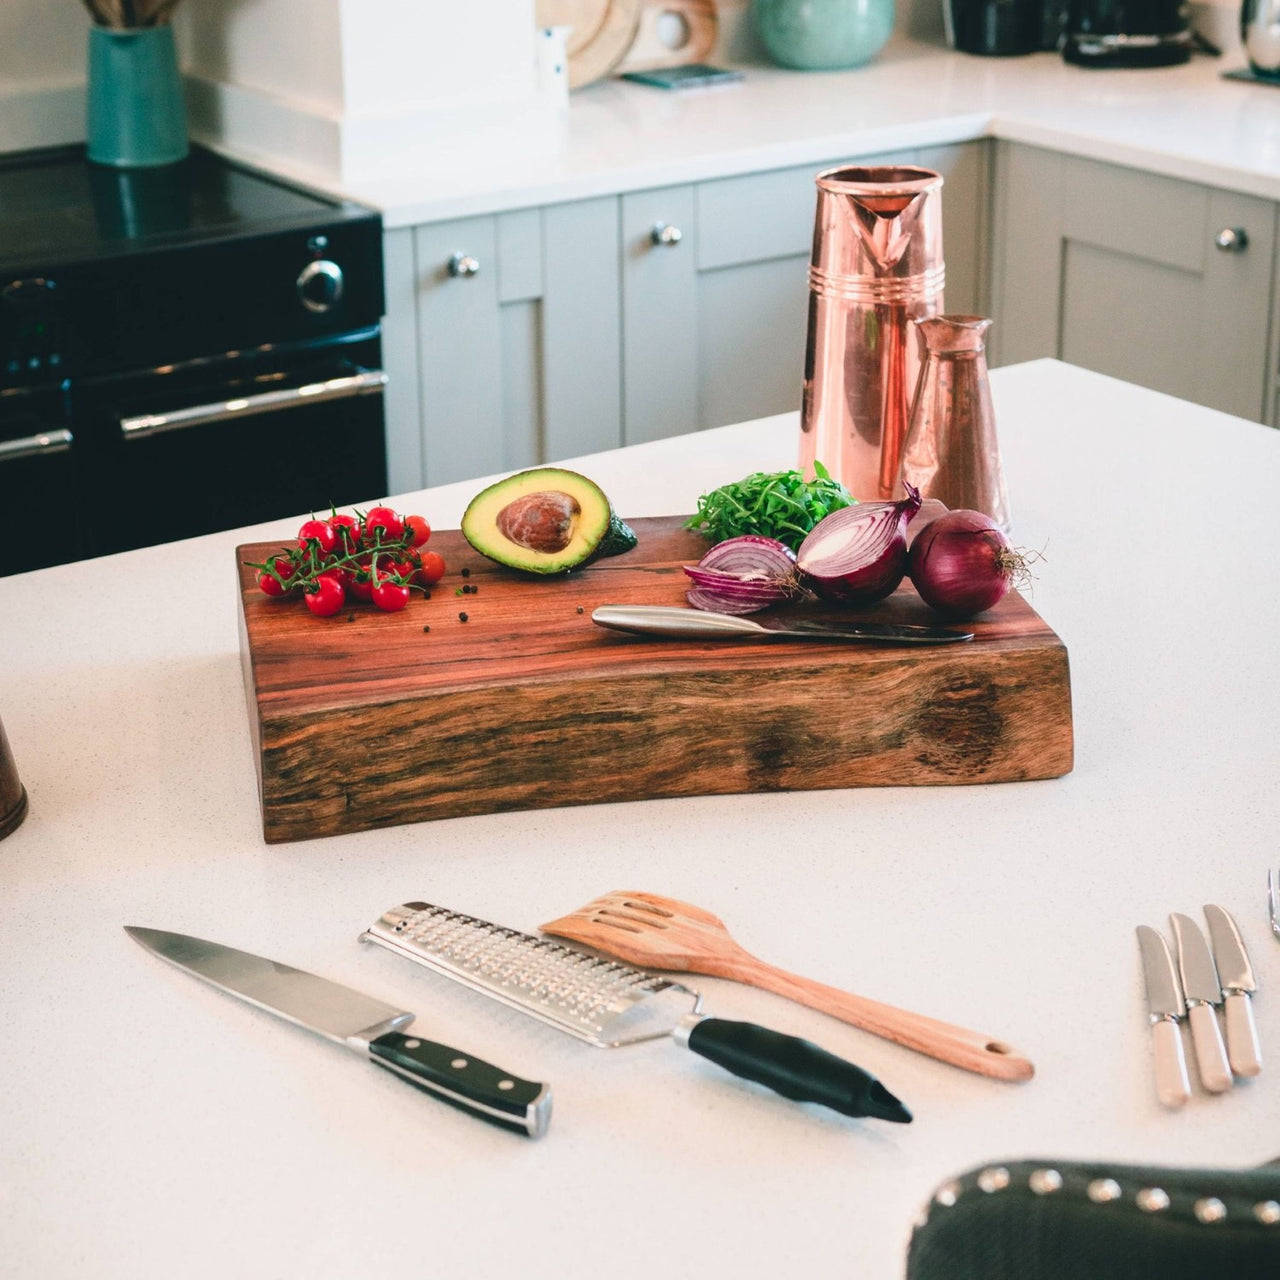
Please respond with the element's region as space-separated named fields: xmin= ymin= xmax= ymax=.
xmin=902 ymin=315 xmax=1009 ymax=532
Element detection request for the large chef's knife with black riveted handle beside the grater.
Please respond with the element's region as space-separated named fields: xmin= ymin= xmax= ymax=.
xmin=125 ymin=925 xmax=552 ymax=1138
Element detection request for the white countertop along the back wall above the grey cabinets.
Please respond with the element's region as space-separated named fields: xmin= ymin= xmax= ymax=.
xmin=332 ymin=38 xmax=1280 ymax=227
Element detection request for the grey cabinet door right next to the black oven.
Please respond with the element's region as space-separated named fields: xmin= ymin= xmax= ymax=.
xmin=383 ymin=196 xmax=622 ymax=492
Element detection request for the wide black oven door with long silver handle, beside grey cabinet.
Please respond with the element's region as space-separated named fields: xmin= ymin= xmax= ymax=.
xmin=73 ymin=337 xmax=387 ymax=556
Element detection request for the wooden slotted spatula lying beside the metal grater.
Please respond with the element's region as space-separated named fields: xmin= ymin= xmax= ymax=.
xmin=541 ymin=891 xmax=1036 ymax=1080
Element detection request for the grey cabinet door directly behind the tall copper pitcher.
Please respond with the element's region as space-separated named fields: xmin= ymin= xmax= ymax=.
xmin=621 ymin=142 xmax=988 ymax=444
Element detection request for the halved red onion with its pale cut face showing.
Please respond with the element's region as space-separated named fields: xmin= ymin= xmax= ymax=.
xmin=796 ymin=484 xmax=920 ymax=604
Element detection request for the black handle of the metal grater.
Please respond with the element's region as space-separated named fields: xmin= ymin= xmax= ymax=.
xmin=676 ymin=1018 xmax=911 ymax=1124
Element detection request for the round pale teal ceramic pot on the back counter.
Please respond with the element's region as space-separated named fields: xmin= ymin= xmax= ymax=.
xmin=751 ymin=0 xmax=893 ymax=72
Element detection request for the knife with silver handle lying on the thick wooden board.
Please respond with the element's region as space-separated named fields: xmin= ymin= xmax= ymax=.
xmin=591 ymin=604 xmax=973 ymax=644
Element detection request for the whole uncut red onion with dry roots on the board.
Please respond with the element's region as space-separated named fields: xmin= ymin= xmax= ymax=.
xmin=908 ymin=508 xmax=1027 ymax=620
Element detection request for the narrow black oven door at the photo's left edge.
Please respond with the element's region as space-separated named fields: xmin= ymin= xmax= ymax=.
xmin=0 ymin=387 xmax=81 ymax=575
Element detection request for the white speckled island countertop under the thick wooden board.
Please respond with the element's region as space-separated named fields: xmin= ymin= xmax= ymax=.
xmin=0 ymin=361 xmax=1280 ymax=1280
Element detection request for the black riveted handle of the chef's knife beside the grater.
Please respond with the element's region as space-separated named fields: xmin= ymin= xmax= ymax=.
xmin=369 ymin=1032 xmax=552 ymax=1138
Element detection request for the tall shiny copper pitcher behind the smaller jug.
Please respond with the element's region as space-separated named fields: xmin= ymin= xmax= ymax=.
xmin=800 ymin=165 xmax=946 ymax=499
